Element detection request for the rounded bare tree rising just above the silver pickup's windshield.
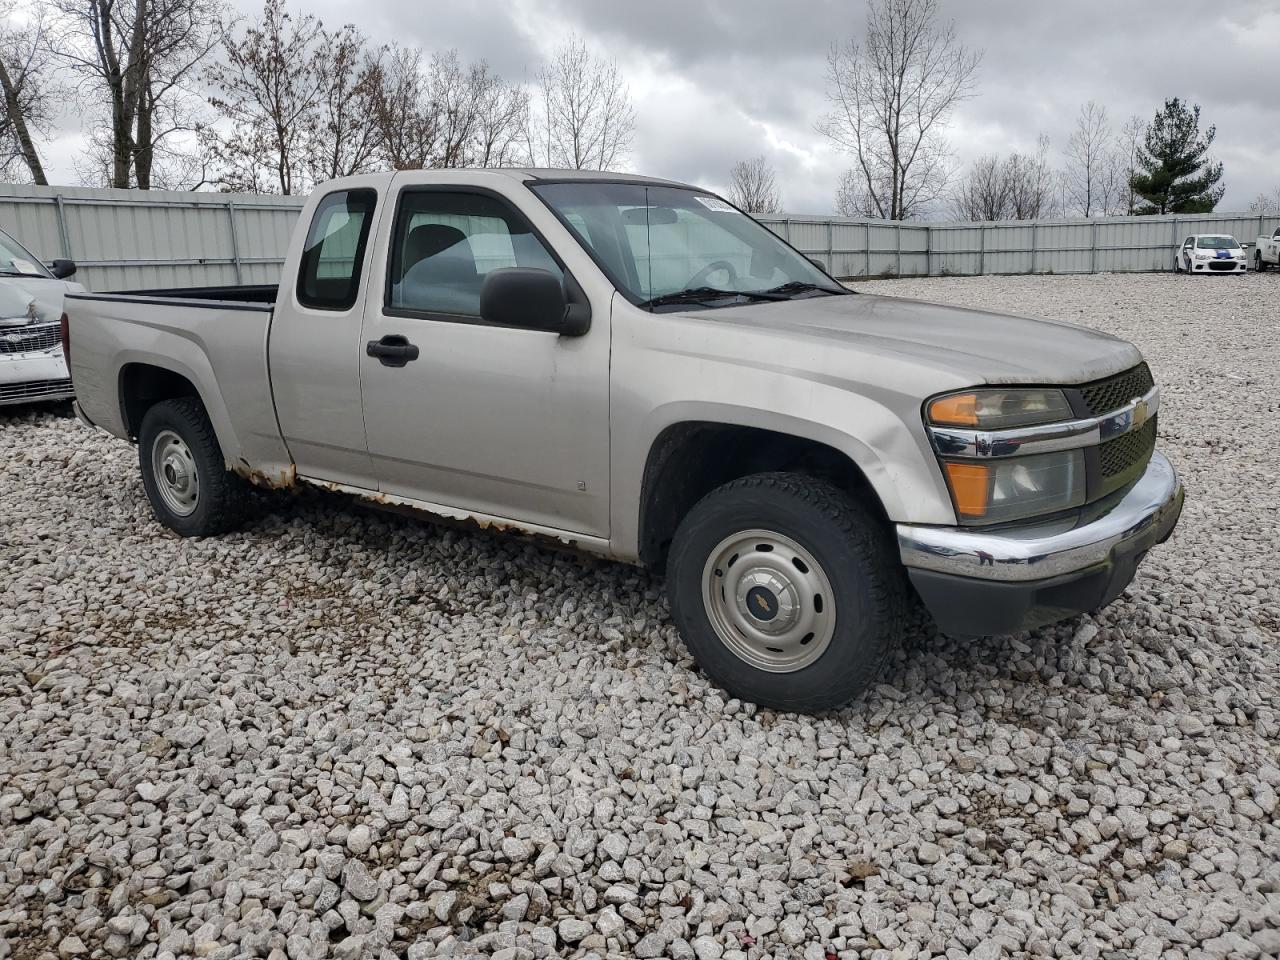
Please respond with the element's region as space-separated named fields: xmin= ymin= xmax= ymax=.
xmin=530 ymin=36 xmax=635 ymax=170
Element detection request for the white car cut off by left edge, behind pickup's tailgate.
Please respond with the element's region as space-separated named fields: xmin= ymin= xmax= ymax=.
xmin=0 ymin=230 xmax=84 ymax=406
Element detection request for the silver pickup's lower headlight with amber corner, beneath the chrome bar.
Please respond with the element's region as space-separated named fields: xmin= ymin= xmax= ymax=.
xmin=942 ymin=451 xmax=1084 ymax=524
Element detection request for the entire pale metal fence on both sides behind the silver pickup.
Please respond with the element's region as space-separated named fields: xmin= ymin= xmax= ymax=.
xmin=0 ymin=184 xmax=1280 ymax=291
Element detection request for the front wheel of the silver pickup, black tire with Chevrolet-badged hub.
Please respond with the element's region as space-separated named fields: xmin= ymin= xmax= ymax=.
xmin=667 ymin=474 xmax=908 ymax=713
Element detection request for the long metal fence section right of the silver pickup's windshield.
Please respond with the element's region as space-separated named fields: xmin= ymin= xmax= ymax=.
xmin=760 ymin=214 xmax=1280 ymax=278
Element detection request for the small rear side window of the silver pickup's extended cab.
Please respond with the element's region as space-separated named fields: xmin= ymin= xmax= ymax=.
xmin=298 ymin=189 xmax=378 ymax=310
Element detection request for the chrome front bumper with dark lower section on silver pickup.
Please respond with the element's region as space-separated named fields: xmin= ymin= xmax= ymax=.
xmin=897 ymin=452 xmax=1183 ymax=636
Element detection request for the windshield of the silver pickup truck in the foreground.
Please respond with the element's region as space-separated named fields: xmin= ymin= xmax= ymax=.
xmin=529 ymin=182 xmax=846 ymax=308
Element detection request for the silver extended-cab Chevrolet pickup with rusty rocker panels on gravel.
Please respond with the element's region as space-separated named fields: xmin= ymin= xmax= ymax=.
xmin=65 ymin=170 xmax=1183 ymax=710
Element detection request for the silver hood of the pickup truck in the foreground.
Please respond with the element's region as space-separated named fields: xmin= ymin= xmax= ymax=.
xmin=698 ymin=293 xmax=1142 ymax=384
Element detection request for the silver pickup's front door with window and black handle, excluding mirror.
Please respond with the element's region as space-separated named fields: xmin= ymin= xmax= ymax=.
xmin=361 ymin=184 xmax=609 ymax=538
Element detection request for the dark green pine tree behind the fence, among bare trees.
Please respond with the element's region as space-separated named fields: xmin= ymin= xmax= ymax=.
xmin=1132 ymin=97 xmax=1226 ymax=215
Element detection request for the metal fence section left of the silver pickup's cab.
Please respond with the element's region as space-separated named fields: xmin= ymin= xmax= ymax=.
xmin=0 ymin=183 xmax=306 ymax=291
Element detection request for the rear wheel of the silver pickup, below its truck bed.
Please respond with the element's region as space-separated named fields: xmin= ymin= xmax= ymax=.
xmin=138 ymin=398 xmax=248 ymax=536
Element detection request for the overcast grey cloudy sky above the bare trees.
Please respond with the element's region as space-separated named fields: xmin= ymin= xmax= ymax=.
xmin=40 ymin=0 xmax=1280 ymax=212
